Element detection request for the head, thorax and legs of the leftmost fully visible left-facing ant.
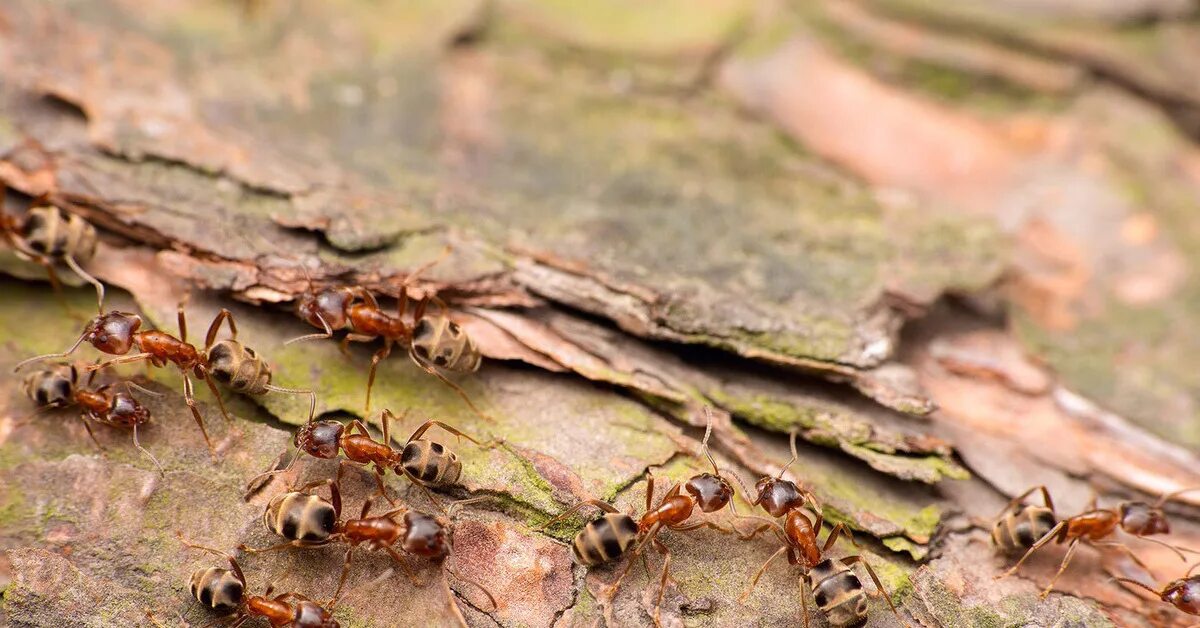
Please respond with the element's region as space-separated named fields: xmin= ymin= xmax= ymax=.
xmin=13 ymin=303 xmax=238 ymax=460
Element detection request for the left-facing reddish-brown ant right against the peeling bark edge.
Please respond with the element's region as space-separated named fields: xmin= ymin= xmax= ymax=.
xmin=284 ymin=254 xmax=493 ymax=421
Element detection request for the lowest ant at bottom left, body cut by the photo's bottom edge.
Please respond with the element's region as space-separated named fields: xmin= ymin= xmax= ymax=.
xmin=180 ymin=537 xmax=341 ymax=628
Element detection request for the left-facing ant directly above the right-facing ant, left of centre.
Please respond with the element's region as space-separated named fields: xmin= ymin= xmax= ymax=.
xmin=246 ymin=409 xmax=479 ymax=508
